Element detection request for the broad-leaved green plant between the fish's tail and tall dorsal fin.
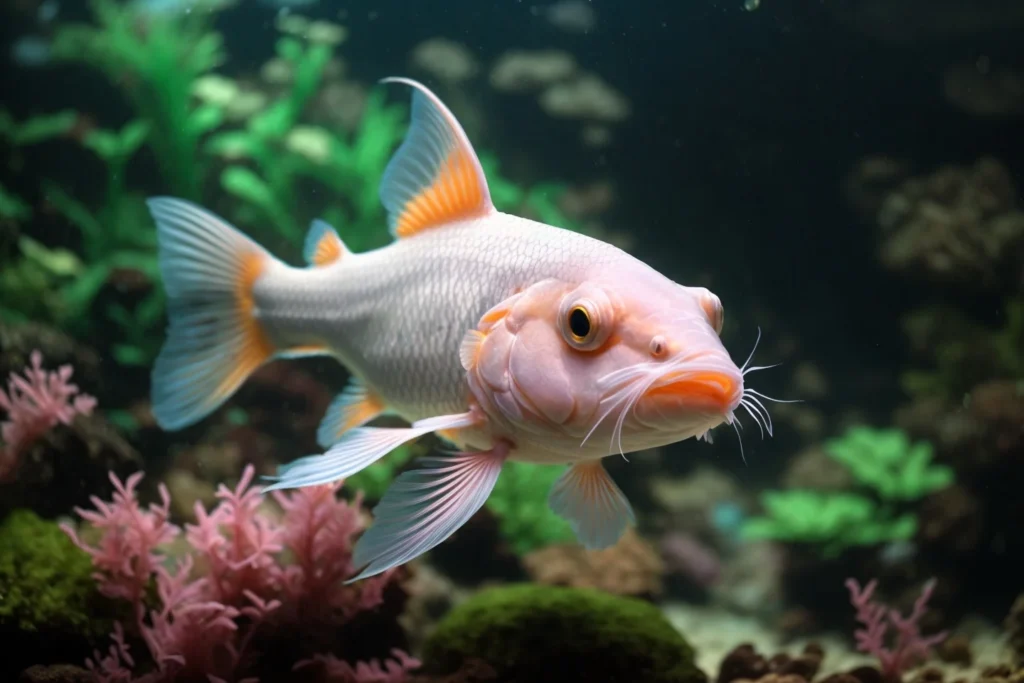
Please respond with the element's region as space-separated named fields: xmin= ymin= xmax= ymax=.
xmin=207 ymin=23 xmax=407 ymax=251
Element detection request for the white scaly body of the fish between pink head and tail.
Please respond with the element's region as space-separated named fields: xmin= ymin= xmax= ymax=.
xmin=255 ymin=213 xmax=622 ymax=421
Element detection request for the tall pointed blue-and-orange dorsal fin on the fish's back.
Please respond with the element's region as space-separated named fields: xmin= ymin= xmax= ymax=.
xmin=380 ymin=78 xmax=495 ymax=239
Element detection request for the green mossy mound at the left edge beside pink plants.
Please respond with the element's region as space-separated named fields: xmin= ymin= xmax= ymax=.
xmin=0 ymin=510 xmax=111 ymax=638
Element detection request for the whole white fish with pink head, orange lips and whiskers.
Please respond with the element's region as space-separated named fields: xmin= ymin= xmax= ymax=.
xmin=147 ymin=77 xmax=771 ymax=582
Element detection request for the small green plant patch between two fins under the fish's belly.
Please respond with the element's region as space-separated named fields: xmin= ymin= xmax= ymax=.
xmin=485 ymin=461 xmax=574 ymax=556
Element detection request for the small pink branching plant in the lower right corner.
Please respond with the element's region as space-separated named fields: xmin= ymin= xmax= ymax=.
xmin=846 ymin=579 xmax=946 ymax=682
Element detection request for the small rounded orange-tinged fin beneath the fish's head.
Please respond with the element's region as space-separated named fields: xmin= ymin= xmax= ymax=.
xmin=548 ymin=460 xmax=636 ymax=550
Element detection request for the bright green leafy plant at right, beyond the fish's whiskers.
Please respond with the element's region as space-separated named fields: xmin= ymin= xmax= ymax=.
xmin=741 ymin=427 xmax=953 ymax=557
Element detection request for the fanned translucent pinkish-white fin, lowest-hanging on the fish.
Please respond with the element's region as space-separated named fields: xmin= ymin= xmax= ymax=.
xmin=346 ymin=442 xmax=509 ymax=583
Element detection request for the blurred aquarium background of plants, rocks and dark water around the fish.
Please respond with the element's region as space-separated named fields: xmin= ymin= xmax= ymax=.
xmin=0 ymin=0 xmax=1024 ymax=683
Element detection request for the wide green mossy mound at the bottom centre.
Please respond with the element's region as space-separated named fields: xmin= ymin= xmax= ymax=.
xmin=423 ymin=585 xmax=706 ymax=683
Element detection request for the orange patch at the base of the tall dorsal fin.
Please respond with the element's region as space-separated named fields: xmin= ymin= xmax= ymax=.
xmin=395 ymin=147 xmax=486 ymax=238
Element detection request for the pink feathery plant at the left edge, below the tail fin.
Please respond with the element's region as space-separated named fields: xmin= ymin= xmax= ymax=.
xmin=0 ymin=350 xmax=96 ymax=481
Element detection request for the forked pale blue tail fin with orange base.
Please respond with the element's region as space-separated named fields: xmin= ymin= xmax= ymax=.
xmin=147 ymin=198 xmax=275 ymax=430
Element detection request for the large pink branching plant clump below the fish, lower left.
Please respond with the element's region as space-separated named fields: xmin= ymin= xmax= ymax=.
xmin=62 ymin=466 xmax=419 ymax=683
